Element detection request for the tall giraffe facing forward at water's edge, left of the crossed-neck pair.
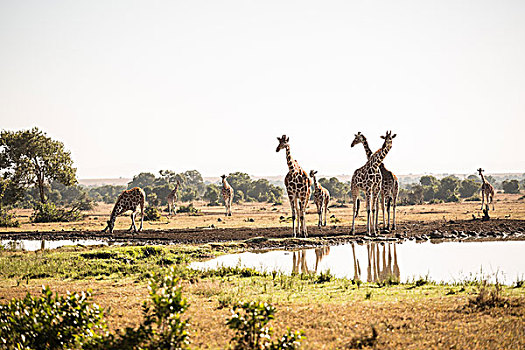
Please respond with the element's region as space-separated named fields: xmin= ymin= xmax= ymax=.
xmin=276 ymin=135 xmax=312 ymax=237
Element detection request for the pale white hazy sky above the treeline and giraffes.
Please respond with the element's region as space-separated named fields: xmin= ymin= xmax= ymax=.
xmin=0 ymin=0 xmax=525 ymax=178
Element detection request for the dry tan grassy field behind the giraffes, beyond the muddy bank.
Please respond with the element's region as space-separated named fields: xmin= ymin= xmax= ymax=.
xmin=0 ymin=194 xmax=525 ymax=233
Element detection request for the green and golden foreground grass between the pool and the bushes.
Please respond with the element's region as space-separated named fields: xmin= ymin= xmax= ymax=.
xmin=0 ymin=244 xmax=525 ymax=349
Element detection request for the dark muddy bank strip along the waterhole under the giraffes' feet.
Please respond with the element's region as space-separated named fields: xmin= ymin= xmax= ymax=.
xmin=0 ymin=219 xmax=525 ymax=249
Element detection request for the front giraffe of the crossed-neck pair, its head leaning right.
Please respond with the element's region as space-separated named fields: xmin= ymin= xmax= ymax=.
xmin=351 ymin=131 xmax=397 ymax=235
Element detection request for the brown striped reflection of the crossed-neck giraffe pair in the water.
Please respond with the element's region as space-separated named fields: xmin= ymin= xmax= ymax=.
xmin=362 ymin=243 xmax=400 ymax=283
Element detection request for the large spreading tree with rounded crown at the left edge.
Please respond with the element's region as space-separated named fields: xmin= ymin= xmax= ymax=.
xmin=0 ymin=127 xmax=77 ymax=203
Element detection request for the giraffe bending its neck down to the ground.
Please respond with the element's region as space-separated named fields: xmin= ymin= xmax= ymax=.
xmin=102 ymin=187 xmax=146 ymax=233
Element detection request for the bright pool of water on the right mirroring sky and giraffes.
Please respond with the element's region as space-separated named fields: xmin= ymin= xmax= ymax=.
xmin=190 ymin=241 xmax=525 ymax=284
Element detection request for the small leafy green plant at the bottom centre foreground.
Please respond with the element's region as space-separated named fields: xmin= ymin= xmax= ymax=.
xmin=226 ymin=301 xmax=304 ymax=350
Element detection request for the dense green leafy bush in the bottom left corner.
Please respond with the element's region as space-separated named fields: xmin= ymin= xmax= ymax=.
xmin=0 ymin=287 xmax=106 ymax=349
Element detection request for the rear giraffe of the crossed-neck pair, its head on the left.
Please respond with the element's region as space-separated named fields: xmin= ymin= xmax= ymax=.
xmin=351 ymin=132 xmax=399 ymax=230
